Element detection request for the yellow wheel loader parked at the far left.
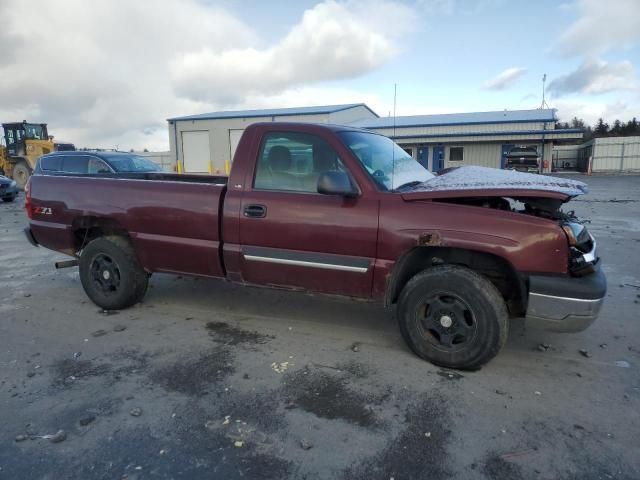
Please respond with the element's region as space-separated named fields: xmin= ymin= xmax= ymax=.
xmin=0 ymin=121 xmax=76 ymax=189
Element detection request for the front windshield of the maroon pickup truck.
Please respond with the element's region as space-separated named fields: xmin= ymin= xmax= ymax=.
xmin=338 ymin=132 xmax=433 ymax=191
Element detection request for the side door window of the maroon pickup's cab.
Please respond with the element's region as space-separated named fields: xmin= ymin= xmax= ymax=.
xmin=253 ymin=132 xmax=345 ymax=193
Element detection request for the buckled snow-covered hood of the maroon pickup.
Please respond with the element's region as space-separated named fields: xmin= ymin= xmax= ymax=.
xmin=402 ymin=166 xmax=588 ymax=201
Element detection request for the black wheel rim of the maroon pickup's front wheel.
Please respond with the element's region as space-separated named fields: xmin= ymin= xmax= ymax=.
xmin=416 ymin=291 xmax=478 ymax=352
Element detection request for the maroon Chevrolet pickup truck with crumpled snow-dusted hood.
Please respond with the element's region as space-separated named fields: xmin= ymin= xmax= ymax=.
xmin=25 ymin=122 xmax=606 ymax=369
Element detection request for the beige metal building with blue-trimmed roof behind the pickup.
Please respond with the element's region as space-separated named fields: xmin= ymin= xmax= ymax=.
xmin=168 ymin=103 xmax=583 ymax=174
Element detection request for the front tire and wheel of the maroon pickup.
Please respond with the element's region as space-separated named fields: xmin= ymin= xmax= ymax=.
xmin=398 ymin=265 xmax=508 ymax=370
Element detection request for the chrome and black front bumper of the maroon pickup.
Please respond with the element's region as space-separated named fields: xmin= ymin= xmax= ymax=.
xmin=526 ymin=265 xmax=607 ymax=332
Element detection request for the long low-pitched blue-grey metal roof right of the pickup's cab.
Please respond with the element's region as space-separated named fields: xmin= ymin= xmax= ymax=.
xmin=349 ymin=108 xmax=556 ymax=128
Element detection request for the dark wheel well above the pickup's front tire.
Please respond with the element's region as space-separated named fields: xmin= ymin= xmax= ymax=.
xmin=385 ymin=247 xmax=527 ymax=316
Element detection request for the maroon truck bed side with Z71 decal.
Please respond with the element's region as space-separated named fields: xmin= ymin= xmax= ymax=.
xmin=31 ymin=173 xmax=227 ymax=276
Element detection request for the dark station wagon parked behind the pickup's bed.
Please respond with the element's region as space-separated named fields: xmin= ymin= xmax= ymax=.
xmin=35 ymin=151 xmax=162 ymax=175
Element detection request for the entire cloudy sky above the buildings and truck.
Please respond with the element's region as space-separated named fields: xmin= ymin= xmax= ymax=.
xmin=0 ymin=0 xmax=640 ymax=150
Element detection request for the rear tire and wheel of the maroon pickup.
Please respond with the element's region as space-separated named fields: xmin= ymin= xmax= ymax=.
xmin=80 ymin=236 xmax=149 ymax=310
